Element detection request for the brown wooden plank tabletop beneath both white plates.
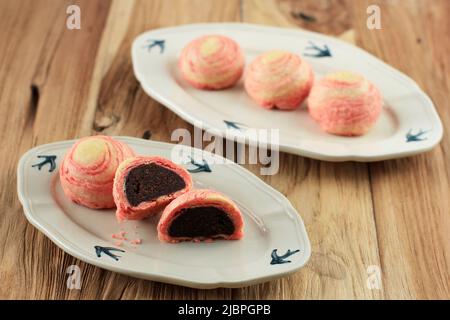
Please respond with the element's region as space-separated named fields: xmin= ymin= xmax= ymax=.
xmin=0 ymin=0 xmax=450 ymax=299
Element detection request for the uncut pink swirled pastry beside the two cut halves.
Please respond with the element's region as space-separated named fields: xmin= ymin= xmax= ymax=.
xmin=59 ymin=136 xmax=134 ymax=209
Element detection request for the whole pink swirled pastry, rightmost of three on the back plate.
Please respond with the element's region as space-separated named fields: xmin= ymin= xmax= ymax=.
xmin=308 ymin=72 xmax=383 ymax=136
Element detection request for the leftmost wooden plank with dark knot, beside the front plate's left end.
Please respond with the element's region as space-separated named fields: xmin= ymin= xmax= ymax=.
xmin=0 ymin=1 xmax=109 ymax=298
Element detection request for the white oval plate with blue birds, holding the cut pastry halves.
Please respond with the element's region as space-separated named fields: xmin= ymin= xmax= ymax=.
xmin=17 ymin=137 xmax=311 ymax=288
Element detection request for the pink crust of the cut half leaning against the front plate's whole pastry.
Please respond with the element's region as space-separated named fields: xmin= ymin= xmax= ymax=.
xmin=113 ymin=157 xmax=192 ymax=221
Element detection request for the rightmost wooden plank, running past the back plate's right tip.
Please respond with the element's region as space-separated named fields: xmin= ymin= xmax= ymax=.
xmin=355 ymin=0 xmax=450 ymax=299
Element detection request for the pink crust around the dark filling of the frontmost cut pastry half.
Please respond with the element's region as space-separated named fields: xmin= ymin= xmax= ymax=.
xmin=158 ymin=189 xmax=244 ymax=243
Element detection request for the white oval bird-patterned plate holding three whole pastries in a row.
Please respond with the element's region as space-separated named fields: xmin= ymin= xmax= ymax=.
xmin=132 ymin=23 xmax=443 ymax=161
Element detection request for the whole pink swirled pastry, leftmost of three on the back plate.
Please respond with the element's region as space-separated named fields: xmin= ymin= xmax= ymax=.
xmin=178 ymin=35 xmax=245 ymax=90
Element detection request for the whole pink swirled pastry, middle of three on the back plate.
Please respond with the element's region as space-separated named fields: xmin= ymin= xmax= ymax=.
xmin=245 ymin=51 xmax=314 ymax=110
